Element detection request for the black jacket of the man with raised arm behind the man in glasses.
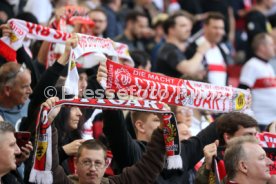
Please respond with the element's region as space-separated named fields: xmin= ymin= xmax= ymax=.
xmin=103 ymin=110 xmax=218 ymax=184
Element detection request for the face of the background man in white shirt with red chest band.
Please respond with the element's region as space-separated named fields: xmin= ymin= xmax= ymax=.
xmin=204 ymin=19 xmax=224 ymax=44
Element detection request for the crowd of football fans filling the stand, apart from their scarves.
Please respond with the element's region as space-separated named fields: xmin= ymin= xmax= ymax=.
xmin=0 ymin=0 xmax=276 ymax=184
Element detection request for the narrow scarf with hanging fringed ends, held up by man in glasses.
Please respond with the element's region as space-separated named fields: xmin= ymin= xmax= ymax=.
xmin=29 ymin=99 xmax=182 ymax=184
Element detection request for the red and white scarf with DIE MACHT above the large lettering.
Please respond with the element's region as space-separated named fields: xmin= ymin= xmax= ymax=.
xmin=101 ymin=60 xmax=251 ymax=112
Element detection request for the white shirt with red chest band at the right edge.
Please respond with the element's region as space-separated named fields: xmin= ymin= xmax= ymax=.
xmin=240 ymin=57 xmax=276 ymax=125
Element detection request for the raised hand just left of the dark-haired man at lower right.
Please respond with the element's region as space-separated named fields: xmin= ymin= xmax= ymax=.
xmin=203 ymin=140 xmax=219 ymax=170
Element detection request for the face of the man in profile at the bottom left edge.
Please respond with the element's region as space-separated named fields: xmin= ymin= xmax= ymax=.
xmin=0 ymin=132 xmax=21 ymax=174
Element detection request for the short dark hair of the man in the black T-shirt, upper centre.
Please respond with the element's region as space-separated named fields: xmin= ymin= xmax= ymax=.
xmin=163 ymin=11 xmax=194 ymax=35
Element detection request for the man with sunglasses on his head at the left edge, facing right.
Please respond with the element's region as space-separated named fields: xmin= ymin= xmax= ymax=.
xmin=0 ymin=62 xmax=33 ymax=125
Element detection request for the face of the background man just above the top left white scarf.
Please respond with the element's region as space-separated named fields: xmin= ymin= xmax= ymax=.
xmin=89 ymin=11 xmax=107 ymax=36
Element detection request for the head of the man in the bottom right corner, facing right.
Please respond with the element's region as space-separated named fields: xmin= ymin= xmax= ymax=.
xmin=224 ymin=136 xmax=273 ymax=184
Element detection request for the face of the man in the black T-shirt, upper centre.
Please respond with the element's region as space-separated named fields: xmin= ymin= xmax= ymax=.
xmin=173 ymin=16 xmax=193 ymax=42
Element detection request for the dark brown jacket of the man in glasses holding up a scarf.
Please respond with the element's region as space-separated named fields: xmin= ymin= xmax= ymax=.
xmin=52 ymin=123 xmax=165 ymax=184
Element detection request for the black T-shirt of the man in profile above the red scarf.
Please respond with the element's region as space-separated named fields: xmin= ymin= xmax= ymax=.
xmin=156 ymin=43 xmax=186 ymax=78
